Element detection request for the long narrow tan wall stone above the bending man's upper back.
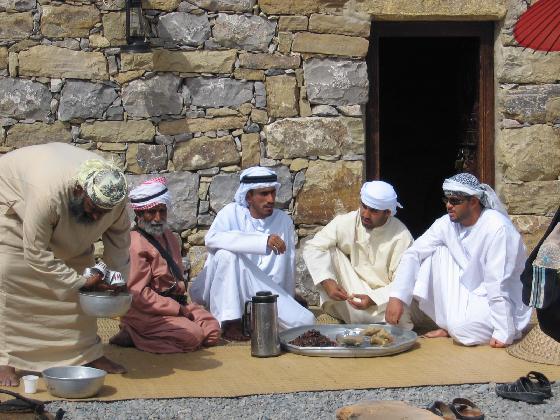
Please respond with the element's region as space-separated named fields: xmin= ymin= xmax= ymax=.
xmin=80 ymin=120 xmax=156 ymax=143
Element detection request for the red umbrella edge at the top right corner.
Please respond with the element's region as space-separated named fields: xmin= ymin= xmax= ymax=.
xmin=513 ymin=0 xmax=560 ymax=52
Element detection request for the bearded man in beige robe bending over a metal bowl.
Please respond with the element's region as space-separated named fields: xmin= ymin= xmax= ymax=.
xmin=0 ymin=143 xmax=130 ymax=386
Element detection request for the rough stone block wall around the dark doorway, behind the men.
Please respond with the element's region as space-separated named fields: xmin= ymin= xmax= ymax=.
xmin=0 ymin=0 xmax=560 ymax=300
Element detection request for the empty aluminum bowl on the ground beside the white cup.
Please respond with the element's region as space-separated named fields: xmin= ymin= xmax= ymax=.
xmin=43 ymin=366 xmax=107 ymax=398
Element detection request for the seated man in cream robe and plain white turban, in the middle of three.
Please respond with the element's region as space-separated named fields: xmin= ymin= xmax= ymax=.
xmin=303 ymin=181 xmax=412 ymax=329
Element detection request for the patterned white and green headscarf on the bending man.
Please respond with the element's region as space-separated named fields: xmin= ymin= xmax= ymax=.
xmin=76 ymin=159 xmax=128 ymax=209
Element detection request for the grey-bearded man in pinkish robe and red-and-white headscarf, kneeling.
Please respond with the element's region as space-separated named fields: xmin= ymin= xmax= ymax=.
xmin=110 ymin=177 xmax=221 ymax=353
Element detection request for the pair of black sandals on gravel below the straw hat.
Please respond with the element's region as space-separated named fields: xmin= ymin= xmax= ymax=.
xmin=496 ymin=370 xmax=552 ymax=404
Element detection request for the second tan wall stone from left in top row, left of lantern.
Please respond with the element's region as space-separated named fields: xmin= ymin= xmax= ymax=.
xmin=41 ymin=4 xmax=101 ymax=38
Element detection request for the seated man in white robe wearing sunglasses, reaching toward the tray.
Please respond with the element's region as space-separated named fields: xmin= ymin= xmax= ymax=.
xmin=385 ymin=173 xmax=531 ymax=347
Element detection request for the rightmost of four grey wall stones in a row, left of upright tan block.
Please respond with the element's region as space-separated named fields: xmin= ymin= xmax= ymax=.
xmin=186 ymin=77 xmax=253 ymax=108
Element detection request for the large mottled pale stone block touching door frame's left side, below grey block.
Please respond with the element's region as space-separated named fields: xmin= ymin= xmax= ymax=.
xmin=265 ymin=117 xmax=364 ymax=159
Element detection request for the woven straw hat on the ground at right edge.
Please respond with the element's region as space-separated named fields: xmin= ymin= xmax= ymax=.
xmin=506 ymin=324 xmax=560 ymax=365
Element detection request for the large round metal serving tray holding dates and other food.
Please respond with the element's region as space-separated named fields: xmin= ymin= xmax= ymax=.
xmin=280 ymin=324 xmax=418 ymax=357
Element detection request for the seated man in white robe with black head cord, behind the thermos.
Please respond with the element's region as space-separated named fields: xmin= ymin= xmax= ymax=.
xmin=190 ymin=167 xmax=315 ymax=340
